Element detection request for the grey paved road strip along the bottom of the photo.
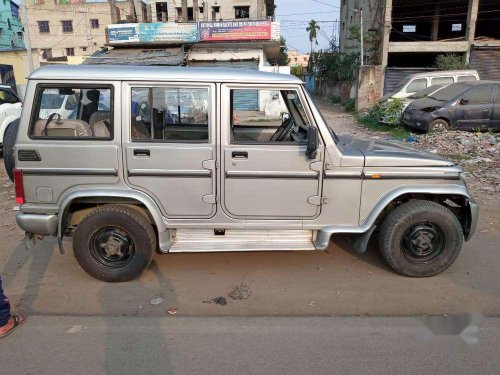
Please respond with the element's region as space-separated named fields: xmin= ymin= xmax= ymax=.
xmin=0 ymin=316 xmax=500 ymax=375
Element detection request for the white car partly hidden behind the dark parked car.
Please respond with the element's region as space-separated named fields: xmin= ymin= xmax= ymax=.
xmin=380 ymin=70 xmax=479 ymax=102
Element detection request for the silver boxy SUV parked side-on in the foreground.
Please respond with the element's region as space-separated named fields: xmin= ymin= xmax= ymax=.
xmin=7 ymin=65 xmax=478 ymax=281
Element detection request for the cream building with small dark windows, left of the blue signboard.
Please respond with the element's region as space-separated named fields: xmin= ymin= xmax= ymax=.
xmin=25 ymin=0 xmax=147 ymax=63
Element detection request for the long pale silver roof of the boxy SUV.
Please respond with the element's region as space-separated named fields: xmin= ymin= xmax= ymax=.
xmin=29 ymin=65 xmax=302 ymax=83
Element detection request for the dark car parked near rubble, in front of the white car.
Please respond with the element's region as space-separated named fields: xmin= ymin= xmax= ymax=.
xmin=403 ymin=81 xmax=500 ymax=131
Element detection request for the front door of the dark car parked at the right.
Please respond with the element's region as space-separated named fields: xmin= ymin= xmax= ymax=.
xmin=456 ymin=85 xmax=493 ymax=130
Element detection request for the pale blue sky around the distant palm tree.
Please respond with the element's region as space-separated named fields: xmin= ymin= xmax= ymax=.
xmin=274 ymin=0 xmax=340 ymax=53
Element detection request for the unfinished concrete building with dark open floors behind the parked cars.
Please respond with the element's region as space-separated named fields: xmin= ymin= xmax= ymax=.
xmin=340 ymin=0 xmax=500 ymax=92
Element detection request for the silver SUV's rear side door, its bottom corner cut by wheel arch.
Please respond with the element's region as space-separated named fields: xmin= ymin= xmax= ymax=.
xmin=123 ymin=83 xmax=216 ymax=218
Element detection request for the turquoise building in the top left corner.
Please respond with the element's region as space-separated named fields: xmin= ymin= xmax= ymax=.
xmin=0 ymin=0 xmax=24 ymax=50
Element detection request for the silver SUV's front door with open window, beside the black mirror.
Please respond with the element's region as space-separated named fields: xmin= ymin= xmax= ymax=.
xmin=221 ymin=84 xmax=324 ymax=219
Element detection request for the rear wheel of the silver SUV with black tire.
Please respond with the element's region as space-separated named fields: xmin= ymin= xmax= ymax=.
xmin=73 ymin=205 xmax=157 ymax=282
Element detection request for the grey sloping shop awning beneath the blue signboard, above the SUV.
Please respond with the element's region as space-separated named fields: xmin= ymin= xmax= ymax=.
xmin=83 ymin=46 xmax=186 ymax=66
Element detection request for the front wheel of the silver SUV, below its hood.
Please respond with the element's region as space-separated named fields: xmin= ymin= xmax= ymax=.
xmin=379 ymin=200 xmax=464 ymax=277
